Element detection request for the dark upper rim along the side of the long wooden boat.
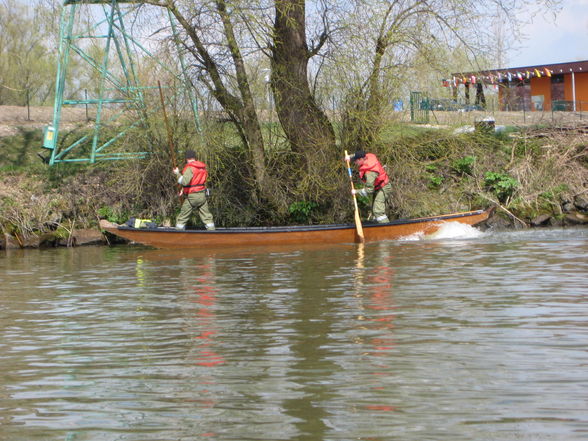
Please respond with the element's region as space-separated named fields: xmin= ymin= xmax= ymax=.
xmin=116 ymin=209 xmax=491 ymax=234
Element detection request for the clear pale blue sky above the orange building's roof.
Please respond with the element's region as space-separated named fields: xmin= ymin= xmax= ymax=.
xmin=500 ymin=0 xmax=588 ymax=67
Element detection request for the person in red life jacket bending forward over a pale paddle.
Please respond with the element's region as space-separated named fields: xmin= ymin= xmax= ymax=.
xmin=346 ymin=150 xmax=392 ymax=224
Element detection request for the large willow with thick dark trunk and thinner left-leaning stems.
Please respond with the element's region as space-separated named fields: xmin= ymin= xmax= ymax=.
xmin=145 ymin=0 xmax=335 ymax=210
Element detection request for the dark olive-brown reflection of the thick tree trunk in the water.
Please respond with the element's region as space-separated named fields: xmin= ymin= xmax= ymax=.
xmin=282 ymin=251 xmax=342 ymax=440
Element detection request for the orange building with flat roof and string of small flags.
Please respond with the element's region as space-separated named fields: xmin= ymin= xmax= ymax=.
xmin=443 ymin=60 xmax=588 ymax=112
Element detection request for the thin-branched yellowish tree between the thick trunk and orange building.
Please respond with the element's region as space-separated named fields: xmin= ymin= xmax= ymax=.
xmin=340 ymin=0 xmax=560 ymax=146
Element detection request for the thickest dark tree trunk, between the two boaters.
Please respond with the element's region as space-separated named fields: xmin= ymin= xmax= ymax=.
xmin=271 ymin=0 xmax=336 ymax=174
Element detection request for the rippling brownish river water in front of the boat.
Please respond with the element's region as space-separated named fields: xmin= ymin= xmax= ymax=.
xmin=0 ymin=226 xmax=588 ymax=441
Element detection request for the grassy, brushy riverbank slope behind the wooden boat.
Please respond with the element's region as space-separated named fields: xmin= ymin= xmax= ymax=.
xmin=0 ymin=118 xmax=588 ymax=248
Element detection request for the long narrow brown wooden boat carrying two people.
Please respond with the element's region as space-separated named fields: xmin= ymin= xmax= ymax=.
xmin=100 ymin=207 xmax=494 ymax=248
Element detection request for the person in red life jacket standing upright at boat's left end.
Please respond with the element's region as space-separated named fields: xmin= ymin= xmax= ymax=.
xmin=173 ymin=150 xmax=214 ymax=230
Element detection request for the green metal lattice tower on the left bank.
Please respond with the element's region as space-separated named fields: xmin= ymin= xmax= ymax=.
xmin=43 ymin=0 xmax=200 ymax=165
